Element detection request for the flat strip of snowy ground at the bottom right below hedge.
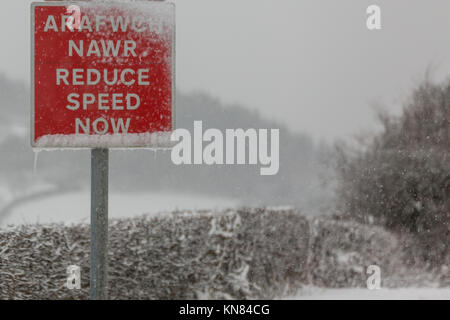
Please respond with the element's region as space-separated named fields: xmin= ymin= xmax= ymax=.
xmin=283 ymin=287 xmax=450 ymax=300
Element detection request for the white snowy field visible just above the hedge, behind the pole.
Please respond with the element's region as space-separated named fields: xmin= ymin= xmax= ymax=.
xmin=1 ymin=190 xmax=237 ymax=225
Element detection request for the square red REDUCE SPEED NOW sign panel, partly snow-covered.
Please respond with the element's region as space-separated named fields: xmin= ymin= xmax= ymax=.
xmin=31 ymin=1 xmax=175 ymax=148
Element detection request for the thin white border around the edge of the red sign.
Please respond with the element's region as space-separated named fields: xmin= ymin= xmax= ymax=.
xmin=30 ymin=1 xmax=176 ymax=150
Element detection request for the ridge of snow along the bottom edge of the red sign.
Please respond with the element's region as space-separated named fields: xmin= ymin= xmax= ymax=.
xmin=34 ymin=132 xmax=174 ymax=149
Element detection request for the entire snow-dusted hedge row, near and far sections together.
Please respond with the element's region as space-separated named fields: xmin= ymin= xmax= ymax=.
xmin=0 ymin=208 xmax=442 ymax=299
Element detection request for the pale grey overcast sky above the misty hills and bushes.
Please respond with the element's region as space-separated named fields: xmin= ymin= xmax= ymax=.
xmin=0 ymin=0 xmax=450 ymax=140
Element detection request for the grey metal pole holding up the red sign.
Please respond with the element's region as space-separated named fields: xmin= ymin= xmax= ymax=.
xmin=89 ymin=149 xmax=109 ymax=300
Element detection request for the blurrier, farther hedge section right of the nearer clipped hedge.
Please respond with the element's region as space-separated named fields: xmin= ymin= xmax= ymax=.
xmin=308 ymin=218 xmax=403 ymax=288
